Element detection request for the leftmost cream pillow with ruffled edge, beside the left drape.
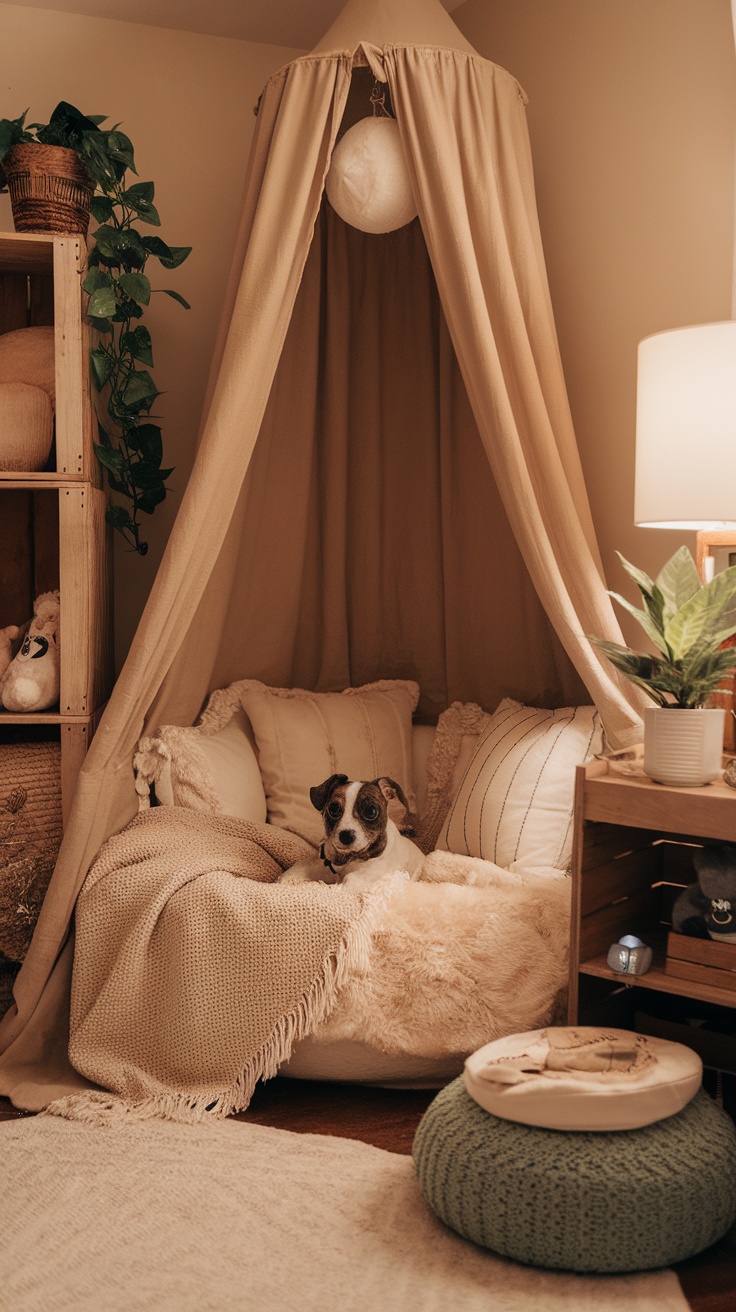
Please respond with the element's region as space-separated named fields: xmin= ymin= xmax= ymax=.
xmin=133 ymin=687 xmax=266 ymax=824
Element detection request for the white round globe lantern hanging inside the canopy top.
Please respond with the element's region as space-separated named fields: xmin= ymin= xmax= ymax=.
xmin=325 ymin=117 xmax=417 ymax=232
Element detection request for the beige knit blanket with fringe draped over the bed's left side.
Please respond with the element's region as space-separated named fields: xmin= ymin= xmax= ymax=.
xmin=56 ymin=807 xmax=382 ymax=1120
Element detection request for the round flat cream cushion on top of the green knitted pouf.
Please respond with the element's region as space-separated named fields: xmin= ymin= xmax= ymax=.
xmin=464 ymin=1026 xmax=703 ymax=1131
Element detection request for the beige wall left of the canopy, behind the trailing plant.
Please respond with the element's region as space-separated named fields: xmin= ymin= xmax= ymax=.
xmin=0 ymin=4 xmax=299 ymax=665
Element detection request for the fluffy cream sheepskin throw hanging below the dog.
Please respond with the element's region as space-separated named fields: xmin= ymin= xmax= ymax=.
xmin=314 ymin=851 xmax=571 ymax=1057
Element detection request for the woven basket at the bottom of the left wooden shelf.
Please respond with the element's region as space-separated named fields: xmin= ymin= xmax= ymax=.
xmin=0 ymin=743 xmax=62 ymax=962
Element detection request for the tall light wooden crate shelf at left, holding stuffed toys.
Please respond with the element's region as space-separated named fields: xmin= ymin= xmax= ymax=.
xmin=0 ymin=232 xmax=113 ymax=819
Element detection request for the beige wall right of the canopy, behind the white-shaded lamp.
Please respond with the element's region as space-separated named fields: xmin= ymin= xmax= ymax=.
xmin=453 ymin=0 xmax=736 ymax=640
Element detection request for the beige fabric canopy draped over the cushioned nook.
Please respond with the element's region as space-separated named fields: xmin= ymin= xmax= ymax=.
xmin=0 ymin=0 xmax=639 ymax=1109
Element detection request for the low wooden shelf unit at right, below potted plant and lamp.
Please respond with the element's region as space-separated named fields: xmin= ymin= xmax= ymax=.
xmin=568 ymin=761 xmax=736 ymax=1073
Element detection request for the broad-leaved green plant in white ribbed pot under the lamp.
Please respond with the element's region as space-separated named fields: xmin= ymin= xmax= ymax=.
xmin=589 ymin=547 xmax=736 ymax=787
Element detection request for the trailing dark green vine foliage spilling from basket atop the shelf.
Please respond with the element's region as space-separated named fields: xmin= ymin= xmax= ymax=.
xmin=0 ymin=101 xmax=192 ymax=555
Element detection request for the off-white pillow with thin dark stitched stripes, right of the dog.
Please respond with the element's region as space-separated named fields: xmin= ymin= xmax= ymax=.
xmin=437 ymin=698 xmax=602 ymax=870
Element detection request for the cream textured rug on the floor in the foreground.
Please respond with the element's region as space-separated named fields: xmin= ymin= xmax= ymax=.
xmin=0 ymin=1117 xmax=687 ymax=1312
